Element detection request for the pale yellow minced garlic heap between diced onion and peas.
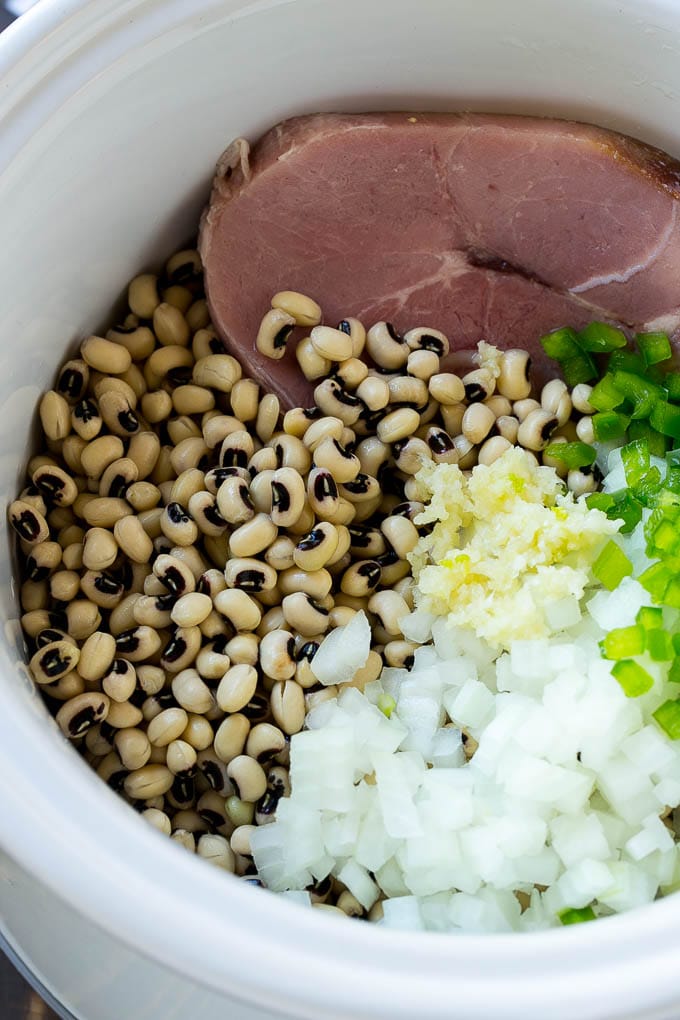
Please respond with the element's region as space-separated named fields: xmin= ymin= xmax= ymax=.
xmin=409 ymin=447 xmax=618 ymax=648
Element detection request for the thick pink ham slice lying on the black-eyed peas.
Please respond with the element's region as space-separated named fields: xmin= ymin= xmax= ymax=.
xmin=200 ymin=113 xmax=680 ymax=406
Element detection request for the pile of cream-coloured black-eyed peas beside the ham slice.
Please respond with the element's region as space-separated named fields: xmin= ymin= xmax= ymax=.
xmin=9 ymin=244 xmax=595 ymax=913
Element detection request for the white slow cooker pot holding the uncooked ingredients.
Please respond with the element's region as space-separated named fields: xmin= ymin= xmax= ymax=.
xmin=0 ymin=0 xmax=680 ymax=1020
